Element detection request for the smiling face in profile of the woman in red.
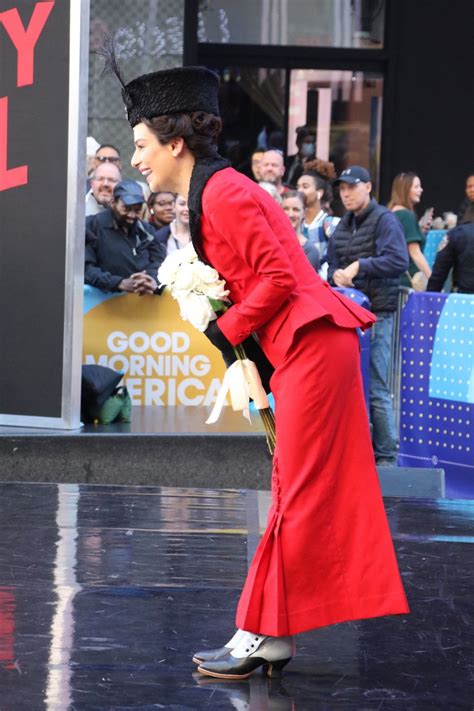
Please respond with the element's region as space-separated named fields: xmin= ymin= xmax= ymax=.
xmin=131 ymin=123 xmax=176 ymax=193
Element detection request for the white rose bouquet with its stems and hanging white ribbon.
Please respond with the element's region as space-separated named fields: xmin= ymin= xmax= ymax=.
xmin=158 ymin=242 xmax=276 ymax=454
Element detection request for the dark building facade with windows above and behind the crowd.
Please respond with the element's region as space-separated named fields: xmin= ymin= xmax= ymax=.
xmin=89 ymin=0 xmax=474 ymax=214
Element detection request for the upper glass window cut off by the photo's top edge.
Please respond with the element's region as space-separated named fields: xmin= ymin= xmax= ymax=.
xmin=198 ymin=0 xmax=385 ymax=49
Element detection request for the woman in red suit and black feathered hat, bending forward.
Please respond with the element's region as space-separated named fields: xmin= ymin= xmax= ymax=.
xmin=103 ymin=58 xmax=408 ymax=679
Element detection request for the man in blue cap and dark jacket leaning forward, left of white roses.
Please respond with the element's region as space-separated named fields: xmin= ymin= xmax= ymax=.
xmin=85 ymin=180 xmax=166 ymax=294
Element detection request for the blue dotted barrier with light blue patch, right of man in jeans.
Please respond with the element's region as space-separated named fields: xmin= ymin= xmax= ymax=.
xmin=399 ymin=292 xmax=474 ymax=498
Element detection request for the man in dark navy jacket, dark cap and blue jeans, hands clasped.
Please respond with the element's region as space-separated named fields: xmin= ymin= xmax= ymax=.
xmin=327 ymin=165 xmax=408 ymax=466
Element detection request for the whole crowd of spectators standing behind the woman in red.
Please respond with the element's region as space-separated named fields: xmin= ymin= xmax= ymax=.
xmin=85 ymin=134 xmax=474 ymax=466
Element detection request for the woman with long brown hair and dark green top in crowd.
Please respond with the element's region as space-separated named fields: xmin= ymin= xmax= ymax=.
xmin=388 ymin=172 xmax=433 ymax=291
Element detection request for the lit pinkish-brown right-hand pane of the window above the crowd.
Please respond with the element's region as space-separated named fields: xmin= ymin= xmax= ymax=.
xmin=287 ymin=69 xmax=383 ymax=195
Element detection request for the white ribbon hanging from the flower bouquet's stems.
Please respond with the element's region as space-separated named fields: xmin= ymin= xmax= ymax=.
xmin=206 ymin=360 xmax=268 ymax=425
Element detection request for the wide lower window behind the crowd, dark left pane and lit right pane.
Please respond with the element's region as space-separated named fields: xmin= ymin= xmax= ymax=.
xmin=217 ymin=67 xmax=383 ymax=197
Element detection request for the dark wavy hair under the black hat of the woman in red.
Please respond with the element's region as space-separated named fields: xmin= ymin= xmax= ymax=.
xmin=143 ymin=111 xmax=222 ymax=158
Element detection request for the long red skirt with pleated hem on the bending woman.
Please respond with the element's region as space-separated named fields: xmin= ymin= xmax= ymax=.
xmin=237 ymin=319 xmax=409 ymax=636
